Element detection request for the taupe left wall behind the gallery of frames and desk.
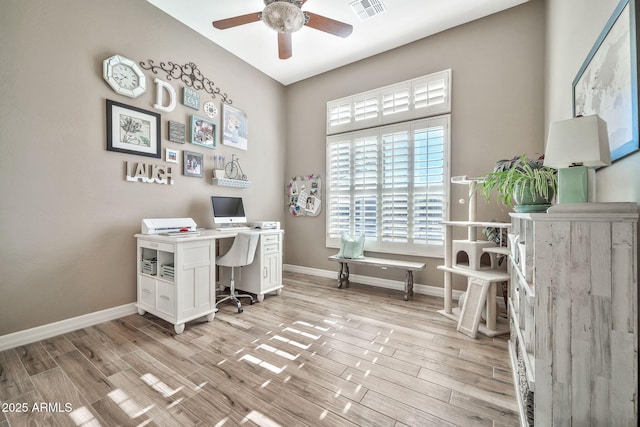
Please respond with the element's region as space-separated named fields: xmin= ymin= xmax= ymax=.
xmin=0 ymin=0 xmax=285 ymax=335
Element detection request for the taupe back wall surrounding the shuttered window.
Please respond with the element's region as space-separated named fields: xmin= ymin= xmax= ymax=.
xmin=285 ymin=0 xmax=544 ymax=288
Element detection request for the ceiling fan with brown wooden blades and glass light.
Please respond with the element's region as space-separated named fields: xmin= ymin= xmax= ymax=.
xmin=213 ymin=0 xmax=353 ymax=59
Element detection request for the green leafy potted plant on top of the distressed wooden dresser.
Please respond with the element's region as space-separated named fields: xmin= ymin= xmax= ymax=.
xmin=482 ymin=155 xmax=558 ymax=212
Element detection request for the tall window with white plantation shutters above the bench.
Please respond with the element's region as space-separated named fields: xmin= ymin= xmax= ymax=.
xmin=326 ymin=70 xmax=450 ymax=256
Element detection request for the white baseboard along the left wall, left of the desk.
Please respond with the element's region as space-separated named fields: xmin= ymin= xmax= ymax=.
xmin=0 ymin=303 xmax=138 ymax=351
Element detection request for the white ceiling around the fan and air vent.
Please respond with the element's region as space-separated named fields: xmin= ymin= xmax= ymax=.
xmin=147 ymin=0 xmax=528 ymax=85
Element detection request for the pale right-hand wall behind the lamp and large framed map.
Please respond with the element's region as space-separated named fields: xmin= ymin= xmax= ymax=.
xmin=545 ymin=0 xmax=640 ymax=203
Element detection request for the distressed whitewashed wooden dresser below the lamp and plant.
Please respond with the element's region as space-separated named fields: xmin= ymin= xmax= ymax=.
xmin=509 ymin=203 xmax=638 ymax=427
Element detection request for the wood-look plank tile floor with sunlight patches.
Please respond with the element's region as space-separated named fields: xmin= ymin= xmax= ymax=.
xmin=0 ymin=273 xmax=518 ymax=427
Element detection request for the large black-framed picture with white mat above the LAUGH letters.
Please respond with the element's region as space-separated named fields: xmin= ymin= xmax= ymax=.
xmin=107 ymin=99 xmax=161 ymax=159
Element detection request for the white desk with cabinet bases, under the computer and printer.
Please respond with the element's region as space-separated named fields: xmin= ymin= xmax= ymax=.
xmin=135 ymin=230 xmax=284 ymax=334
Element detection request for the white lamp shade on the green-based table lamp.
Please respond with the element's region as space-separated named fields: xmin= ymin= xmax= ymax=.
xmin=544 ymin=115 xmax=611 ymax=169
